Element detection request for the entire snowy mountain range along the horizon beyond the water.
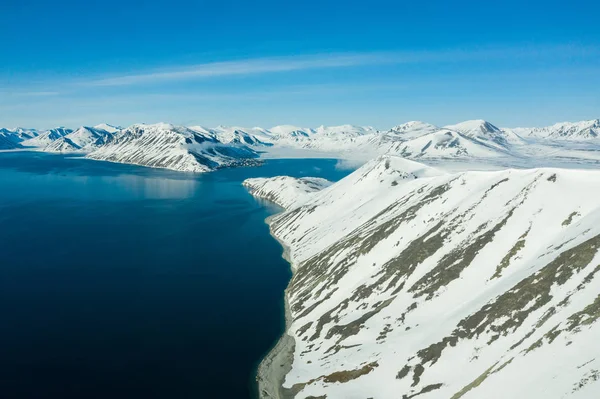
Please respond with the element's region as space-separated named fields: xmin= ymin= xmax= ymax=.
xmin=0 ymin=119 xmax=600 ymax=172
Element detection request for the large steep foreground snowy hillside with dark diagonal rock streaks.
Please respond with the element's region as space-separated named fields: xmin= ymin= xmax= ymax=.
xmin=258 ymin=156 xmax=600 ymax=399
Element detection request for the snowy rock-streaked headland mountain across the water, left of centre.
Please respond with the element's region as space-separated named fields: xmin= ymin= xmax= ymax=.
xmin=88 ymin=123 xmax=258 ymax=172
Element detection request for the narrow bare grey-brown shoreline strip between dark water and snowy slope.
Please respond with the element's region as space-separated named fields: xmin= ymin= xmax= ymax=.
xmin=256 ymin=213 xmax=296 ymax=399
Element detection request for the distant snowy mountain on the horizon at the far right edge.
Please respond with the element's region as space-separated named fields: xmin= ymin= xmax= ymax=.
xmin=506 ymin=119 xmax=600 ymax=141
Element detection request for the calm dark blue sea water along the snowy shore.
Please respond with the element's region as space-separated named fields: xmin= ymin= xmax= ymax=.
xmin=0 ymin=152 xmax=350 ymax=399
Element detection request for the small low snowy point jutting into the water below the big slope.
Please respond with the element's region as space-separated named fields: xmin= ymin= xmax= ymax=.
xmin=243 ymin=176 xmax=331 ymax=208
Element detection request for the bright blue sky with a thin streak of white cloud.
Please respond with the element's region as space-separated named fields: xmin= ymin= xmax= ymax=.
xmin=0 ymin=0 xmax=600 ymax=128
